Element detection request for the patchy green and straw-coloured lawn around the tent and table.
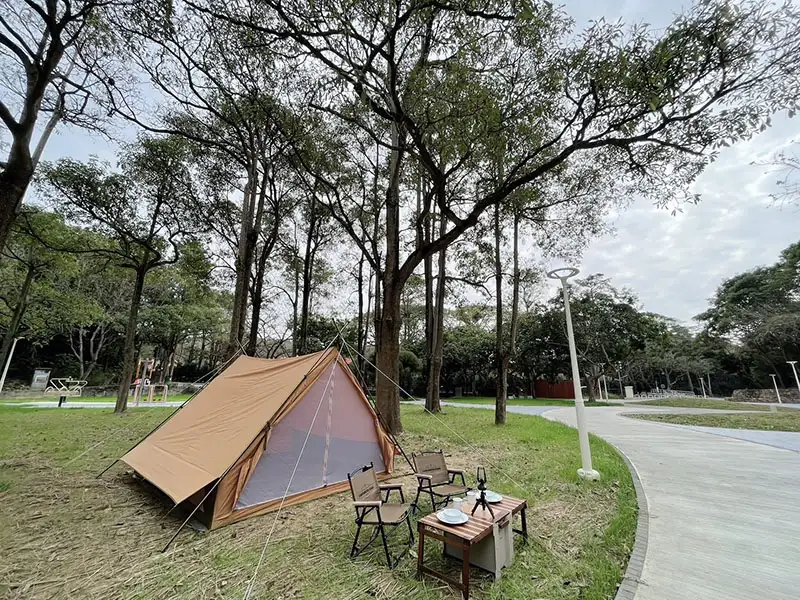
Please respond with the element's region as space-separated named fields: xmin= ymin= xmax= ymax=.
xmin=0 ymin=406 xmax=637 ymax=600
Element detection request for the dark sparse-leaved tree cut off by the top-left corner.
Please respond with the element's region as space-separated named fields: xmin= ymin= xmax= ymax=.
xmin=0 ymin=0 xmax=116 ymax=247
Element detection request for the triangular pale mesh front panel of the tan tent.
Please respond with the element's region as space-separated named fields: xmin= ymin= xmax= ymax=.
xmin=235 ymin=361 xmax=386 ymax=510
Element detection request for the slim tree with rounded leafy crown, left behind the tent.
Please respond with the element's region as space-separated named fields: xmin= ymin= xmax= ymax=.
xmin=38 ymin=138 xmax=195 ymax=413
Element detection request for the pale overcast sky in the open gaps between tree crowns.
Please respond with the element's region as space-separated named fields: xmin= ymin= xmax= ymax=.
xmin=34 ymin=0 xmax=800 ymax=321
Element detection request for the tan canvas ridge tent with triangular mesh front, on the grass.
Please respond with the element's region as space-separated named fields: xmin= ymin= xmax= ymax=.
xmin=121 ymin=349 xmax=395 ymax=528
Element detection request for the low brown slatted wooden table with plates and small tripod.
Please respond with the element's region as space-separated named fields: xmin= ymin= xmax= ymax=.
xmin=417 ymin=496 xmax=528 ymax=600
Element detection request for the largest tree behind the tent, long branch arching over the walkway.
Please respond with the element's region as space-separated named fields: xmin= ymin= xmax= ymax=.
xmin=159 ymin=0 xmax=800 ymax=432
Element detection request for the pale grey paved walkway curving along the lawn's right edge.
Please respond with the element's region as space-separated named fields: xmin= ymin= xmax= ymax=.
xmin=536 ymin=406 xmax=800 ymax=600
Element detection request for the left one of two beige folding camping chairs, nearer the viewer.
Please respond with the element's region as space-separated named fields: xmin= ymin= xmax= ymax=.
xmin=347 ymin=463 xmax=414 ymax=569
